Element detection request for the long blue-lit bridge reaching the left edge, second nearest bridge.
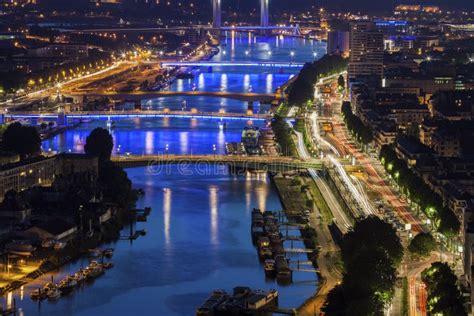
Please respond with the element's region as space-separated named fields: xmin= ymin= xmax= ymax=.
xmin=3 ymin=110 xmax=272 ymax=125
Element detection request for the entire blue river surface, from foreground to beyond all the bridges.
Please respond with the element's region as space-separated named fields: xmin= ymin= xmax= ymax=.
xmin=4 ymin=35 xmax=325 ymax=316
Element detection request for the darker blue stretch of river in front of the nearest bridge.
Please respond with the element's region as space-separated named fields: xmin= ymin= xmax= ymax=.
xmin=3 ymin=167 xmax=316 ymax=316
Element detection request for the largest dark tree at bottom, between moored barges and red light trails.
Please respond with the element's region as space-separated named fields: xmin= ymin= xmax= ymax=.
xmin=323 ymin=216 xmax=403 ymax=316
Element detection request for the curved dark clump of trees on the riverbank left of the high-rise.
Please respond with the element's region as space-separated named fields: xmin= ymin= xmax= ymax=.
xmin=288 ymin=55 xmax=347 ymax=106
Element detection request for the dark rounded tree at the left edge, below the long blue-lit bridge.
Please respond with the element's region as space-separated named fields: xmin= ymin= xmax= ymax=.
xmin=2 ymin=122 xmax=41 ymax=158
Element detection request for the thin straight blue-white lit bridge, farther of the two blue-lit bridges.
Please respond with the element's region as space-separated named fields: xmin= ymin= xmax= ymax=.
xmin=161 ymin=61 xmax=304 ymax=68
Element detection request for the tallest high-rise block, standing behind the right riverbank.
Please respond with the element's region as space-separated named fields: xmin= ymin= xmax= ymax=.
xmin=349 ymin=21 xmax=384 ymax=84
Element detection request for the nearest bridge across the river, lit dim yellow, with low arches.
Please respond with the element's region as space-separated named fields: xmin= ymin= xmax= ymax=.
xmin=112 ymin=154 xmax=323 ymax=172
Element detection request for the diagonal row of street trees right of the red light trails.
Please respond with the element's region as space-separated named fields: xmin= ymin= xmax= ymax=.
xmin=380 ymin=145 xmax=460 ymax=238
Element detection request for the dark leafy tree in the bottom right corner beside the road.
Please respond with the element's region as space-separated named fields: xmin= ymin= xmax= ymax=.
xmin=421 ymin=262 xmax=467 ymax=316
